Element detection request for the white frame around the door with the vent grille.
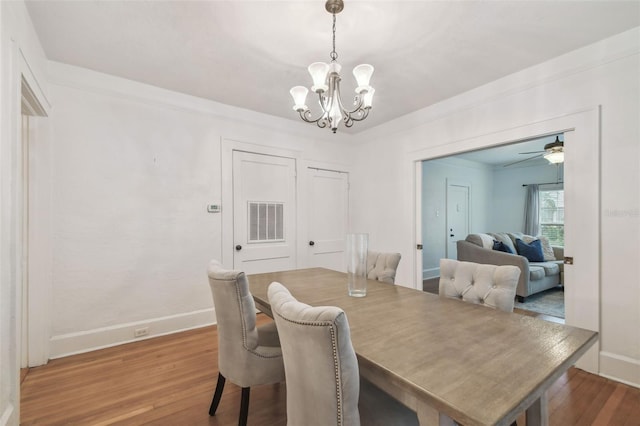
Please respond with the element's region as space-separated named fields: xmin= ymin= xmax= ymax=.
xmin=220 ymin=137 xmax=301 ymax=269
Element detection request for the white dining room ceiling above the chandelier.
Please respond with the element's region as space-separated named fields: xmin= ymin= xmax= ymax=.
xmin=26 ymin=0 xmax=640 ymax=132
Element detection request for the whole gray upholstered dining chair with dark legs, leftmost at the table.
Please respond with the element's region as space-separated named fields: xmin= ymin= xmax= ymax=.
xmin=208 ymin=260 xmax=284 ymax=425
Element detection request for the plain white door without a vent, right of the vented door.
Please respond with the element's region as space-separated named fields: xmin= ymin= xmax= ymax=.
xmin=307 ymin=167 xmax=349 ymax=271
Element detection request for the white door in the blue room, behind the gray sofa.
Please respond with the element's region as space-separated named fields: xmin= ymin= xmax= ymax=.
xmin=447 ymin=183 xmax=469 ymax=259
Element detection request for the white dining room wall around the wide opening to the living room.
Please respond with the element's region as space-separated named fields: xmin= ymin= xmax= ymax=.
xmin=352 ymin=28 xmax=640 ymax=386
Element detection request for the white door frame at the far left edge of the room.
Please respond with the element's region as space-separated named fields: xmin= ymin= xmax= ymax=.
xmin=16 ymin=60 xmax=52 ymax=368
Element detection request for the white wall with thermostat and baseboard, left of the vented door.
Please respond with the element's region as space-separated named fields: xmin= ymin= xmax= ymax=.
xmin=45 ymin=62 xmax=351 ymax=357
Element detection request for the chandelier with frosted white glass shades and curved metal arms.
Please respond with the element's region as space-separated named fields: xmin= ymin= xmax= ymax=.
xmin=289 ymin=0 xmax=375 ymax=133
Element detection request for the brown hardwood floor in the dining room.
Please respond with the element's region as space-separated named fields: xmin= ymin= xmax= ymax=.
xmin=21 ymin=315 xmax=640 ymax=426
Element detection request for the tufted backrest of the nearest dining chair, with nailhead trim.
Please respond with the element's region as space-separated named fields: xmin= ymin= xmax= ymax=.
xmin=268 ymin=282 xmax=360 ymax=426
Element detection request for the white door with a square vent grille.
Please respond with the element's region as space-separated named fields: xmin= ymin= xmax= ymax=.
xmin=233 ymin=151 xmax=296 ymax=274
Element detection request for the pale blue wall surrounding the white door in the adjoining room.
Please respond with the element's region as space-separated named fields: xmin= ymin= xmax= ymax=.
xmin=422 ymin=158 xmax=494 ymax=279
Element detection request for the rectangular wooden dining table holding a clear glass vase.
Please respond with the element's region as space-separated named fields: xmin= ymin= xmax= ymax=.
xmin=248 ymin=268 xmax=598 ymax=426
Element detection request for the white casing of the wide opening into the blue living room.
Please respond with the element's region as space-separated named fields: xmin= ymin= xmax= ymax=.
xmin=408 ymin=106 xmax=602 ymax=374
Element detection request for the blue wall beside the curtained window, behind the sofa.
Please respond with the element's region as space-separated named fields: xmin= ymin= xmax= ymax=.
xmin=487 ymin=164 xmax=562 ymax=232
